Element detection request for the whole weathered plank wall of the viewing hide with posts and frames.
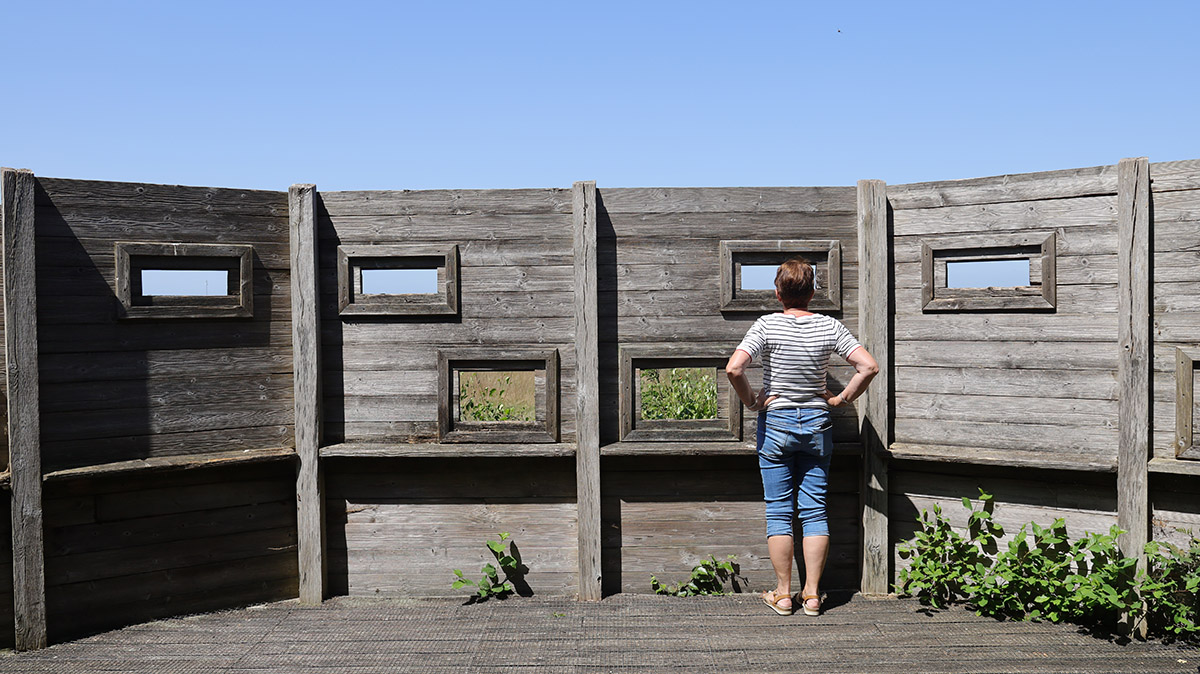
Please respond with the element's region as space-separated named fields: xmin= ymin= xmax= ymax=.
xmin=0 ymin=160 xmax=1200 ymax=649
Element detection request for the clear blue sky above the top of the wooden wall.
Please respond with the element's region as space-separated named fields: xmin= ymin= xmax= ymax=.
xmin=0 ymin=0 xmax=1200 ymax=189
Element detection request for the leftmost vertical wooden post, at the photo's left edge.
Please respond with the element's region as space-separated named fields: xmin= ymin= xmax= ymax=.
xmin=0 ymin=169 xmax=46 ymax=650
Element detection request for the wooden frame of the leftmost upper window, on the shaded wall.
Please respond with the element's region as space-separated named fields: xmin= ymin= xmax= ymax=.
xmin=113 ymin=241 xmax=254 ymax=319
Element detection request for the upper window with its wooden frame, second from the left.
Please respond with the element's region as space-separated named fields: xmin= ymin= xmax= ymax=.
xmin=337 ymin=245 xmax=458 ymax=317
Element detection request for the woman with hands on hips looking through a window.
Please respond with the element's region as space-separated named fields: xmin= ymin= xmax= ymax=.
xmin=725 ymin=259 xmax=880 ymax=615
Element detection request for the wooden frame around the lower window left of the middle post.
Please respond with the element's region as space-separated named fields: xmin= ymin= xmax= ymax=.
xmin=438 ymin=348 xmax=560 ymax=444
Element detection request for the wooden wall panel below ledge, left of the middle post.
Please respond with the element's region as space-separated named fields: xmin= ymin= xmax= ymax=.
xmin=325 ymin=457 xmax=578 ymax=597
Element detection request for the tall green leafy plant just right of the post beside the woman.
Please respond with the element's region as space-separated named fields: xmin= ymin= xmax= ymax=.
xmin=898 ymin=489 xmax=1004 ymax=608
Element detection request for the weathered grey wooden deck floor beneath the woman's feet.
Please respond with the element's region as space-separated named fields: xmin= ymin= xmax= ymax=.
xmin=0 ymin=595 xmax=1200 ymax=674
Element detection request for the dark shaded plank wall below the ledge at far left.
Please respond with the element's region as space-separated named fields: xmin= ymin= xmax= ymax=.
xmin=44 ymin=462 xmax=298 ymax=640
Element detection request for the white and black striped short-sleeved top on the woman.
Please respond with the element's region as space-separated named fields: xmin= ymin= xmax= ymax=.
xmin=738 ymin=313 xmax=860 ymax=409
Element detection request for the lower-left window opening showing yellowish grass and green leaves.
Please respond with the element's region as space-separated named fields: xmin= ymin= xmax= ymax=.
xmin=455 ymin=369 xmax=546 ymax=422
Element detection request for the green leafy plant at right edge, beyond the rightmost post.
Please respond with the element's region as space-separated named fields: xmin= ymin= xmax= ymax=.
xmin=1138 ymin=532 xmax=1200 ymax=640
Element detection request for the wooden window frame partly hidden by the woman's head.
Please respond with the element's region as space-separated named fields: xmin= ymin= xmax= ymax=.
xmin=720 ymin=239 xmax=841 ymax=313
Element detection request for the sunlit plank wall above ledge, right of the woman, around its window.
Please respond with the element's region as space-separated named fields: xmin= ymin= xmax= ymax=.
xmin=888 ymin=167 xmax=1118 ymax=468
